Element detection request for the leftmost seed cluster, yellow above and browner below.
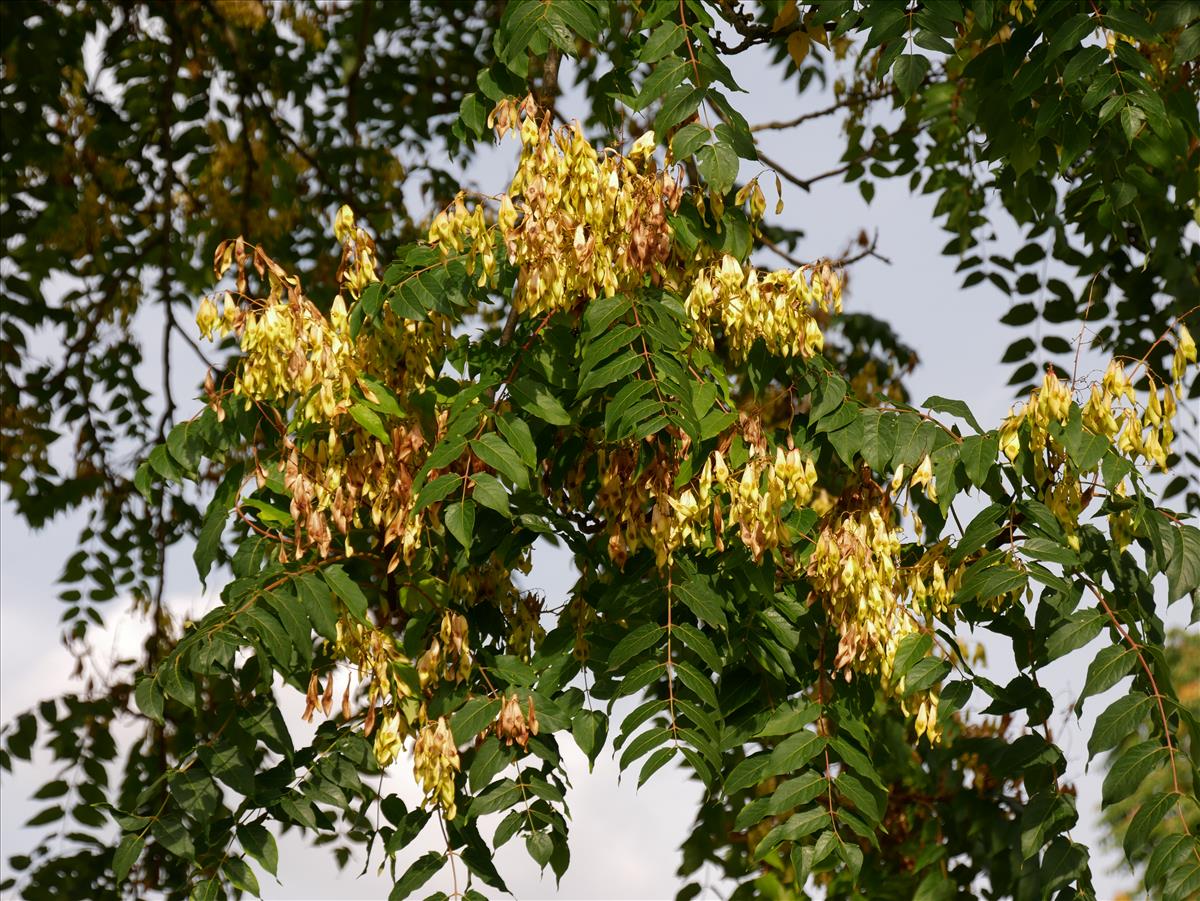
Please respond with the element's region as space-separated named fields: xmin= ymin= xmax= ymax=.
xmin=197 ymin=206 xmax=451 ymax=567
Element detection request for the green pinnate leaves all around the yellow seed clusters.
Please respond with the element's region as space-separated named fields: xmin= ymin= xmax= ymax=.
xmin=0 ymin=0 xmax=1200 ymax=897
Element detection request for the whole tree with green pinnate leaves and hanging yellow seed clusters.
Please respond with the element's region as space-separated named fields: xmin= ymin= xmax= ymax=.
xmin=0 ymin=0 xmax=1200 ymax=897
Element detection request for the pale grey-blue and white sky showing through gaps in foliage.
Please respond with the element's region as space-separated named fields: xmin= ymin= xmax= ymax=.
xmin=0 ymin=33 xmax=1186 ymax=899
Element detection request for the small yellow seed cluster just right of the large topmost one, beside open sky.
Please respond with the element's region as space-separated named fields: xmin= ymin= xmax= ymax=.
xmin=684 ymin=254 xmax=841 ymax=360
